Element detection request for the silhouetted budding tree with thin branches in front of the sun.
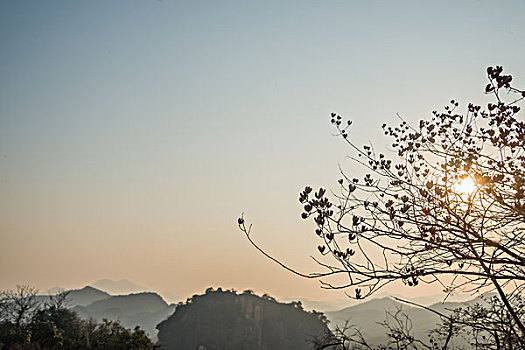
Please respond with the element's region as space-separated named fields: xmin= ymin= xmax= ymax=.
xmin=238 ymin=66 xmax=525 ymax=347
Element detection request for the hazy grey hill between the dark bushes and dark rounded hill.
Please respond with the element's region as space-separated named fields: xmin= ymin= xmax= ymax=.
xmin=73 ymin=293 xmax=175 ymax=339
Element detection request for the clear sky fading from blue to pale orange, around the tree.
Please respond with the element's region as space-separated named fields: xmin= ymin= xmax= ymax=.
xmin=0 ymin=0 xmax=525 ymax=300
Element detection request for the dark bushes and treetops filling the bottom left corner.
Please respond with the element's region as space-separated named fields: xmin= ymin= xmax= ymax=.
xmin=0 ymin=286 xmax=157 ymax=350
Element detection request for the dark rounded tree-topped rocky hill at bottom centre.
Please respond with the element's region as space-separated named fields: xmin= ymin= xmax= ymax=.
xmin=157 ymin=289 xmax=328 ymax=350
